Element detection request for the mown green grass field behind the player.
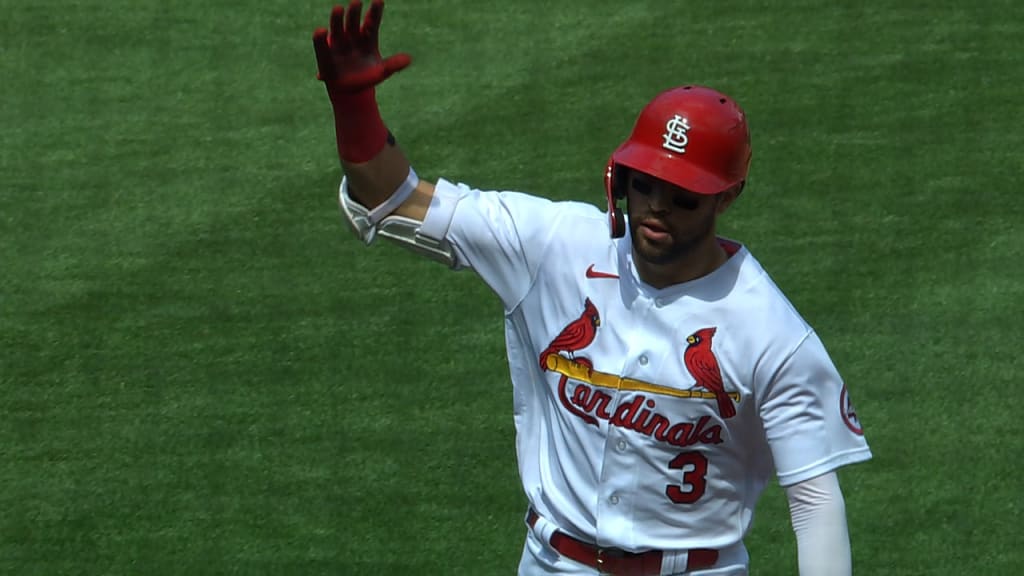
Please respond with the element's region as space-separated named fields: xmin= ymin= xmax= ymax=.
xmin=0 ymin=0 xmax=1024 ymax=576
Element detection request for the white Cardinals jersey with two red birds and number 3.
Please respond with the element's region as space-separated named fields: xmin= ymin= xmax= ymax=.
xmin=411 ymin=179 xmax=871 ymax=553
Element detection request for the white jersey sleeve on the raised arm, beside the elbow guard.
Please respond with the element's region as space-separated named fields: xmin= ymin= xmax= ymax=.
xmin=421 ymin=179 xmax=560 ymax=311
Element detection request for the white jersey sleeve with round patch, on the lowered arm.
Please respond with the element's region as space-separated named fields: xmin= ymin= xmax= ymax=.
xmin=760 ymin=331 xmax=871 ymax=486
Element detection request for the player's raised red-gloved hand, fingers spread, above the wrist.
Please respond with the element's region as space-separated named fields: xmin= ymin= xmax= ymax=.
xmin=313 ymin=0 xmax=413 ymax=94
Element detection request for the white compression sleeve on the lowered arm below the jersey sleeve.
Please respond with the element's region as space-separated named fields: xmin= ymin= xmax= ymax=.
xmin=785 ymin=471 xmax=853 ymax=576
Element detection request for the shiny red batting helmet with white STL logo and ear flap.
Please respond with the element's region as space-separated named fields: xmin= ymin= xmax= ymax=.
xmin=604 ymin=86 xmax=751 ymax=238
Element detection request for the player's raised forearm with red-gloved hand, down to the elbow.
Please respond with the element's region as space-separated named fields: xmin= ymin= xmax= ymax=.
xmin=313 ymin=0 xmax=433 ymax=220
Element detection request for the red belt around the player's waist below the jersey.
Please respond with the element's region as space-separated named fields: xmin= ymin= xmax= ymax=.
xmin=526 ymin=508 xmax=718 ymax=576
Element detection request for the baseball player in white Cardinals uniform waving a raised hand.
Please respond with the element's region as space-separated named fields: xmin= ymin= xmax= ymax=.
xmin=313 ymin=0 xmax=871 ymax=576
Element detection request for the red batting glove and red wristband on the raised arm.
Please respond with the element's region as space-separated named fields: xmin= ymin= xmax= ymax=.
xmin=313 ymin=0 xmax=413 ymax=163
